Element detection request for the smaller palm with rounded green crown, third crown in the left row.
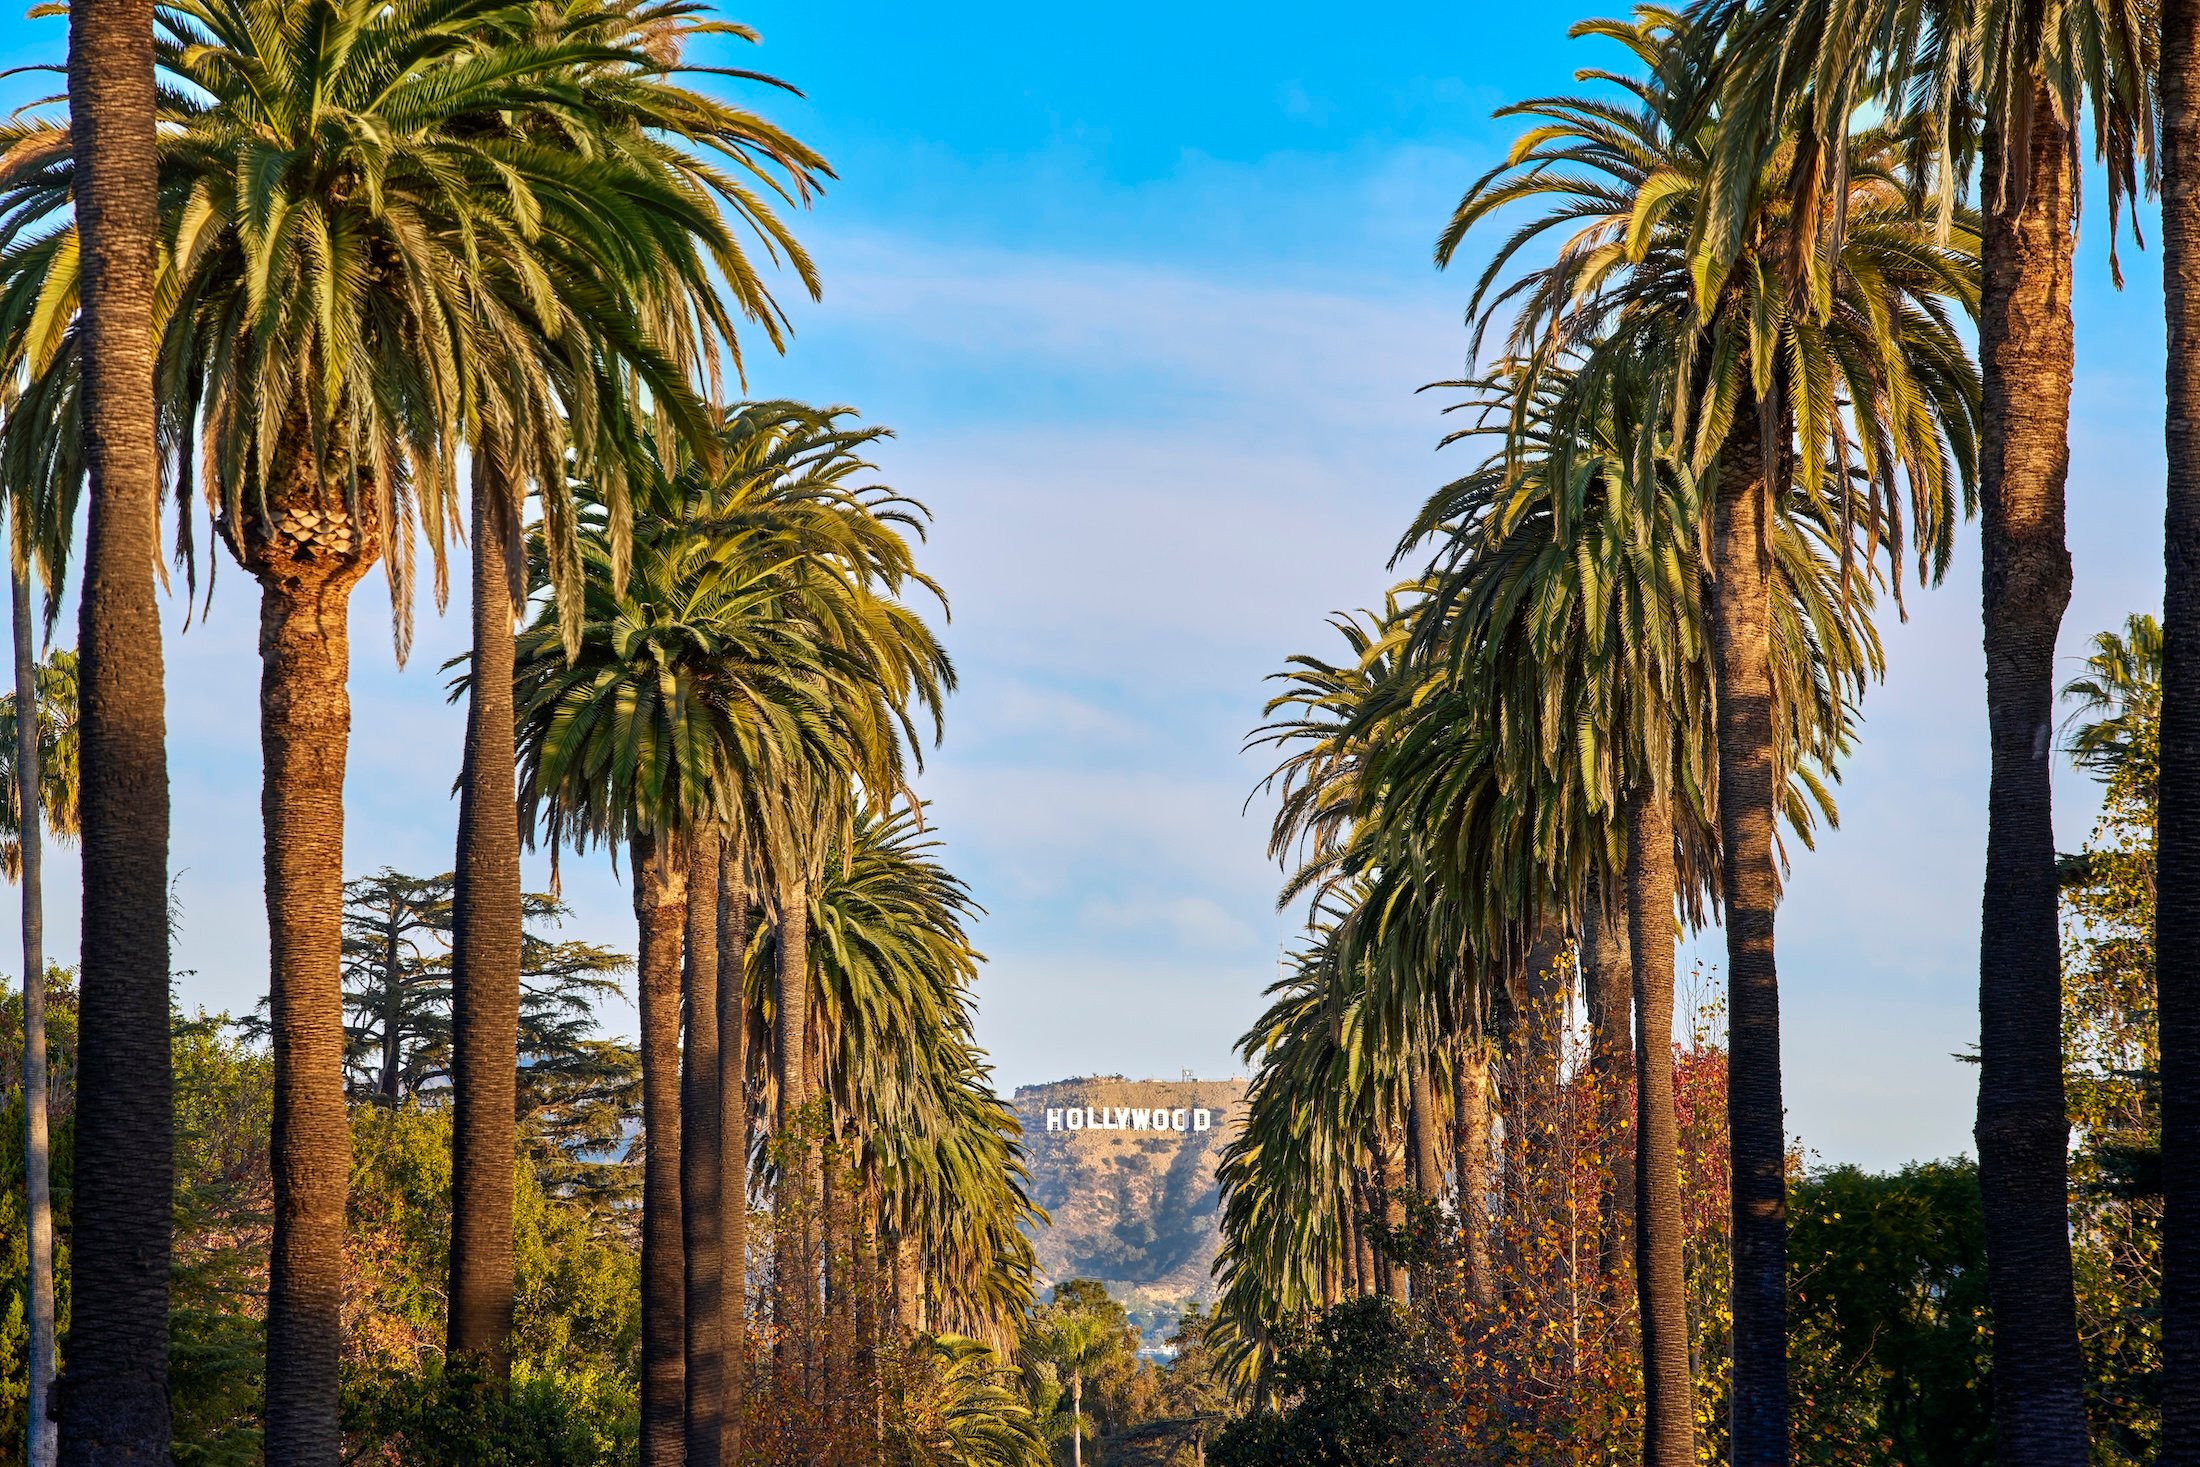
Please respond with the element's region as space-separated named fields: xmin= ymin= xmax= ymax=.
xmin=515 ymin=453 xmax=897 ymax=1463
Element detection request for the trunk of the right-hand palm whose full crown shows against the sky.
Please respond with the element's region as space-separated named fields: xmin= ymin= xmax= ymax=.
xmin=1707 ymin=404 xmax=1789 ymax=1467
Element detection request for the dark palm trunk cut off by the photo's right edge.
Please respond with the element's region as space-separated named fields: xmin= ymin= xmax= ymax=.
xmin=2154 ymin=0 xmax=2200 ymax=1467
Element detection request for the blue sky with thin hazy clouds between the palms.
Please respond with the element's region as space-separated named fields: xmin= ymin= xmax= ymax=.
xmin=0 ymin=0 xmax=2163 ymax=1166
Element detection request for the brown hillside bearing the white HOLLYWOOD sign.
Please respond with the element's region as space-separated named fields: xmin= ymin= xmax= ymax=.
xmin=1014 ymin=1076 xmax=1245 ymax=1306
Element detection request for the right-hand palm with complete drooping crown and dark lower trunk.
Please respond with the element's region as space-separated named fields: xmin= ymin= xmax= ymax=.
xmin=1437 ymin=9 xmax=1980 ymax=1463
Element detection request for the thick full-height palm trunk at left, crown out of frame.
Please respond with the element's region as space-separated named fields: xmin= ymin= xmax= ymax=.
xmin=59 ymin=0 xmax=176 ymax=1467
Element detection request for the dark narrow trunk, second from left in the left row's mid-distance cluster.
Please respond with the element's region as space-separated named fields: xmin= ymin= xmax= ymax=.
xmin=680 ymin=829 xmax=726 ymax=1467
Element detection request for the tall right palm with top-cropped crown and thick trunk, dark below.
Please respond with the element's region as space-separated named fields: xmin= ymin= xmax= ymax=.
xmin=1696 ymin=0 xmax=2147 ymax=1467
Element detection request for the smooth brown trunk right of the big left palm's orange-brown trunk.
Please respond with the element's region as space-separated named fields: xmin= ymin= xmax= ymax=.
xmin=449 ymin=459 xmax=526 ymax=1381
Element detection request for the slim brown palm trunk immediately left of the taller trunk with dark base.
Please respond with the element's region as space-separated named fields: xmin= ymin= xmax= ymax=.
xmin=1628 ymin=792 xmax=1696 ymax=1467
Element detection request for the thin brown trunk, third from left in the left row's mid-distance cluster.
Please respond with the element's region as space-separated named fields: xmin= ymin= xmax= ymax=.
xmin=717 ymin=842 xmax=748 ymax=1463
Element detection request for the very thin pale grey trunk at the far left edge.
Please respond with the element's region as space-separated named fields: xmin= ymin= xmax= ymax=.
xmin=11 ymin=543 xmax=59 ymax=1467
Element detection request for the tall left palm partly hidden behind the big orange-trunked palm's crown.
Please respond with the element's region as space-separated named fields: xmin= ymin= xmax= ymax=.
xmin=449 ymin=2 xmax=829 ymax=1372
